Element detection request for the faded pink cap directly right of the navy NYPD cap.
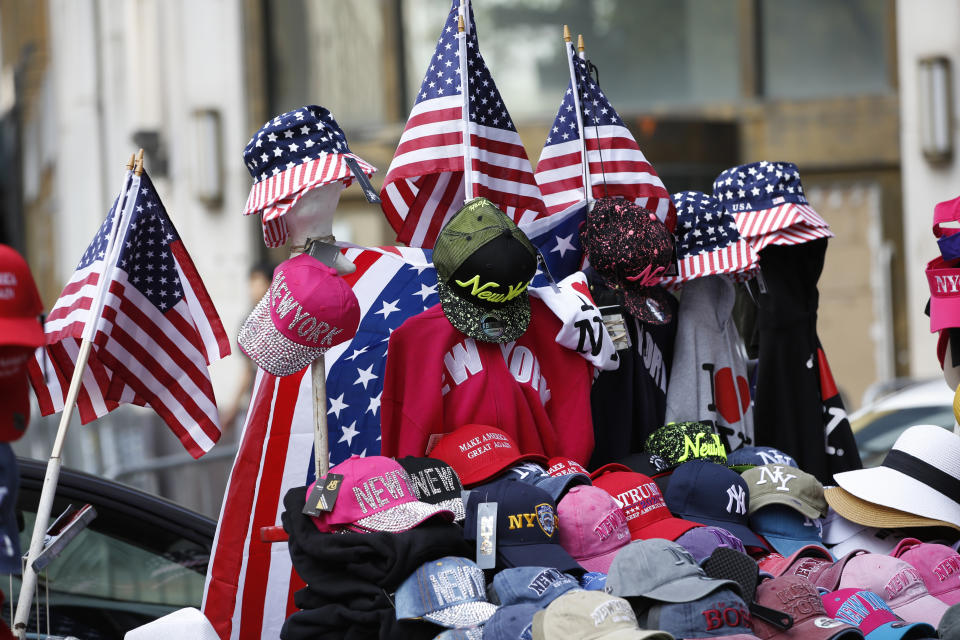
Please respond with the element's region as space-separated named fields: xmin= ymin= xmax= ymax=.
xmin=557 ymin=486 xmax=630 ymax=573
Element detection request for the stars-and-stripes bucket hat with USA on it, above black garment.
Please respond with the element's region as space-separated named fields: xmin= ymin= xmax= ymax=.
xmin=713 ymin=160 xmax=833 ymax=251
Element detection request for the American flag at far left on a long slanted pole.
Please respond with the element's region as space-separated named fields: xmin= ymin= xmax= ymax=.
xmin=30 ymin=173 xmax=230 ymax=457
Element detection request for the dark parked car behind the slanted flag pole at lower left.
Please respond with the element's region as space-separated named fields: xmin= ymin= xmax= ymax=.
xmin=0 ymin=458 xmax=216 ymax=640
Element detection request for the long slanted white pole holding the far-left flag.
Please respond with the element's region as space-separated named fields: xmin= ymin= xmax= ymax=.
xmin=13 ymin=149 xmax=143 ymax=640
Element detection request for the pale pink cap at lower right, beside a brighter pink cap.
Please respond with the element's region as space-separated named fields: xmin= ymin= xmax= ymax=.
xmin=836 ymin=553 xmax=949 ymax=626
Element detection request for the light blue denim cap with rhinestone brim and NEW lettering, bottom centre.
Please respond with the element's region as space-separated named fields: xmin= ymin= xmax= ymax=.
xmin=394 ymin=556 xmax=497 ymax=629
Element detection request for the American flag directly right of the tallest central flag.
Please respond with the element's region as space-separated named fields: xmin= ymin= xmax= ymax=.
xmin=536 ymin=48 xmax=676 ymax=231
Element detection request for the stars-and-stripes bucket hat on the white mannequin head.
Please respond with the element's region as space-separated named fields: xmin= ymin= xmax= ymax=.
xmin=243 ymin=104 xmax=377 ymax=247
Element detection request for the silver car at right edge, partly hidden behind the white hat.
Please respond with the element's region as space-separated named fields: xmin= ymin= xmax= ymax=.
xmin=849 ymin=378 xmax=954 ymax=467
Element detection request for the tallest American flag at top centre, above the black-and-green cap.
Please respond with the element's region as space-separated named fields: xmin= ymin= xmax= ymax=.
xmin=380 ymin=0 xmax=546 ymax=248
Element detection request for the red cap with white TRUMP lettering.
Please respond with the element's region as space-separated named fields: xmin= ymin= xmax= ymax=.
xmin=593 ymin=471 xmax=700 ymax=540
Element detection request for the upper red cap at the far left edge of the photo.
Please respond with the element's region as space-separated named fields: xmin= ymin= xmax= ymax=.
xmin=0 ymin=244 xmax=45 ymax=347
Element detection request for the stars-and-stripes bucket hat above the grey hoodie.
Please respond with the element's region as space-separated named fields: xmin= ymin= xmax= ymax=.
xmin=664 ymin=191 xmax=760 ymax=284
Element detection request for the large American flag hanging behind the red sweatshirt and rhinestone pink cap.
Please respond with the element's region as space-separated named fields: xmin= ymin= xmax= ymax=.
xmin=203 ymin=247 xmax=439 ymax=638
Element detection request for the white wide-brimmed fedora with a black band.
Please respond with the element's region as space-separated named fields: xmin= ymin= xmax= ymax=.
xmin=833 ymin=424 xmax=960 ymax=526
